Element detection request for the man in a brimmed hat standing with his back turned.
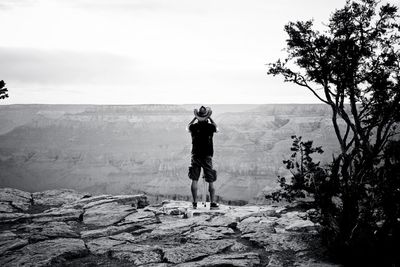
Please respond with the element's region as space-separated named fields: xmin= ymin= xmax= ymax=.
xmin=187 ymin=106 xmax=219 ymax=209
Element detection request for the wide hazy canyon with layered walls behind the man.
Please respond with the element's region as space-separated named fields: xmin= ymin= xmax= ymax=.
xmin=0 ymin=104 xmax=338 ymax=204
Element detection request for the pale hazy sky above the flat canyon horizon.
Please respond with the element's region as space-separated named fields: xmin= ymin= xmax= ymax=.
xmin=0 ymin=0 xmax=390 ymax=104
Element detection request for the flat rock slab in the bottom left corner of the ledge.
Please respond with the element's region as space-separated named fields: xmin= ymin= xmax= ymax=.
xmin=0 ymin=238 xmax=88 ymax=266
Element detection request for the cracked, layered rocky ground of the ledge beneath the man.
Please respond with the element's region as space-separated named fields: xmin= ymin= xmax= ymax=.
xmin=0 ymin=188 xmax=336 ymax=267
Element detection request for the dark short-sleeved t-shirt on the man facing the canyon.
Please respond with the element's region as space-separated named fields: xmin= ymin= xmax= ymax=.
xmin=189 ymin=122 xmax=217 ymax=157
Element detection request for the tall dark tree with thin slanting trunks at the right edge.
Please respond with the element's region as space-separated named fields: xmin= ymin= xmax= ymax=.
xmin=268 ymin=0 xmax=400 ymax=262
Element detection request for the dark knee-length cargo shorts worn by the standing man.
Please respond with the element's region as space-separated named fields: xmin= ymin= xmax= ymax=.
xmin=188 ymin=155 xmax=217 ymax=183
